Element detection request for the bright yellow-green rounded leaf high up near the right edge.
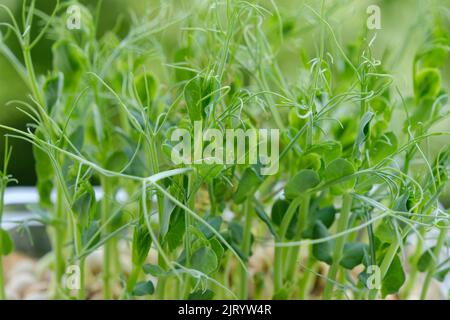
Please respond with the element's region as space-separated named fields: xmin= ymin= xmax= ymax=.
xmin=414 ymin=68 xmax=441 ymax=99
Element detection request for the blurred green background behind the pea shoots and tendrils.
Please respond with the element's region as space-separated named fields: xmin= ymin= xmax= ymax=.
xmin=0 ymin=0 xmax=450 ymax=185
